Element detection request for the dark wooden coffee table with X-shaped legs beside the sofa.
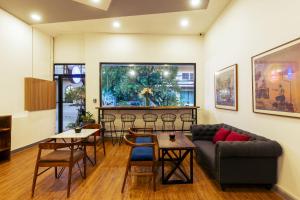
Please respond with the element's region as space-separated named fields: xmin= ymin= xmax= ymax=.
xmin=157 ymin=132 xmax=196 ymax=184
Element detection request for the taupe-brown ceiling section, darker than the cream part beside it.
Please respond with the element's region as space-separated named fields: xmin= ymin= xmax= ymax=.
xmin=0 ymin=0 xmax=209 ymax=24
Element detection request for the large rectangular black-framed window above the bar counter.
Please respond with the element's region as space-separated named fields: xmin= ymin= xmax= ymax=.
xmin=100 ymin=63 xmax=195 ymax=106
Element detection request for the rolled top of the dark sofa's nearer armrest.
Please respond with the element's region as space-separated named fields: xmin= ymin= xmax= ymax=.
xmin=216 ymin=140 xmax=282 ymax=158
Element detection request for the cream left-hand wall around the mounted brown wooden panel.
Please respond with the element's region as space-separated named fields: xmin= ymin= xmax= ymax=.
xmin=0 ymin=9 xmax=55 ymax=150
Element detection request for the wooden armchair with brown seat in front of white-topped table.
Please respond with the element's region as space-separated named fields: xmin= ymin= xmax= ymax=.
xmin=31 ymin=139 xmax=86 ymax=197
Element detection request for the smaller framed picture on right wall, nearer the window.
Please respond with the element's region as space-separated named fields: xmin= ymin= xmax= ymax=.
xmin=215 ymin=64 xmax=238 ymax=111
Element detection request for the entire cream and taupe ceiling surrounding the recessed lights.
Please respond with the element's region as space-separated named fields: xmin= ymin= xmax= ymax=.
xmin=0 ymin=0 xmax=231 ymax=36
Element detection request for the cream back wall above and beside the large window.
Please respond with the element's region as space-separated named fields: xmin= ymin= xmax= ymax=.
xmin=54 ymin=34 xmax=204 ymax=127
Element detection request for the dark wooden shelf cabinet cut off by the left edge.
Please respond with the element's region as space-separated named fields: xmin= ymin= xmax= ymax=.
xmin=0 ymin=116 xmax=11 ymax=162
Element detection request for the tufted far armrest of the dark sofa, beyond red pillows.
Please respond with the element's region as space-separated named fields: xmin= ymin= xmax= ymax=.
xmin=191 ymin=124 xmax=222 ymax=141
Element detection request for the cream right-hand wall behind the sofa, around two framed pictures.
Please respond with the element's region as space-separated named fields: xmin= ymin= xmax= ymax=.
xmin=204 ymin=0 xmax=300 ymax=199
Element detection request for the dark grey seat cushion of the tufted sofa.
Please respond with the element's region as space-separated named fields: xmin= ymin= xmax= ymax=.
xmin=194 ymin=140 xmax=216 ymax=173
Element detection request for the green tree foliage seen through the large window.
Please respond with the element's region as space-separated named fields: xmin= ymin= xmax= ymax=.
xmin=101 ymin=65 xmax=180 ymax=106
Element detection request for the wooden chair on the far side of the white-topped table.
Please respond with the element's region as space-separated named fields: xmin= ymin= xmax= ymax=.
xmin=83 ymin=124 xmax=105 ymax=165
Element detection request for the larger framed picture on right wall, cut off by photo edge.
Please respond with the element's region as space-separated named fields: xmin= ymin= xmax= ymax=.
xmin=252 ymin=38 xmax=300 ymax=118
